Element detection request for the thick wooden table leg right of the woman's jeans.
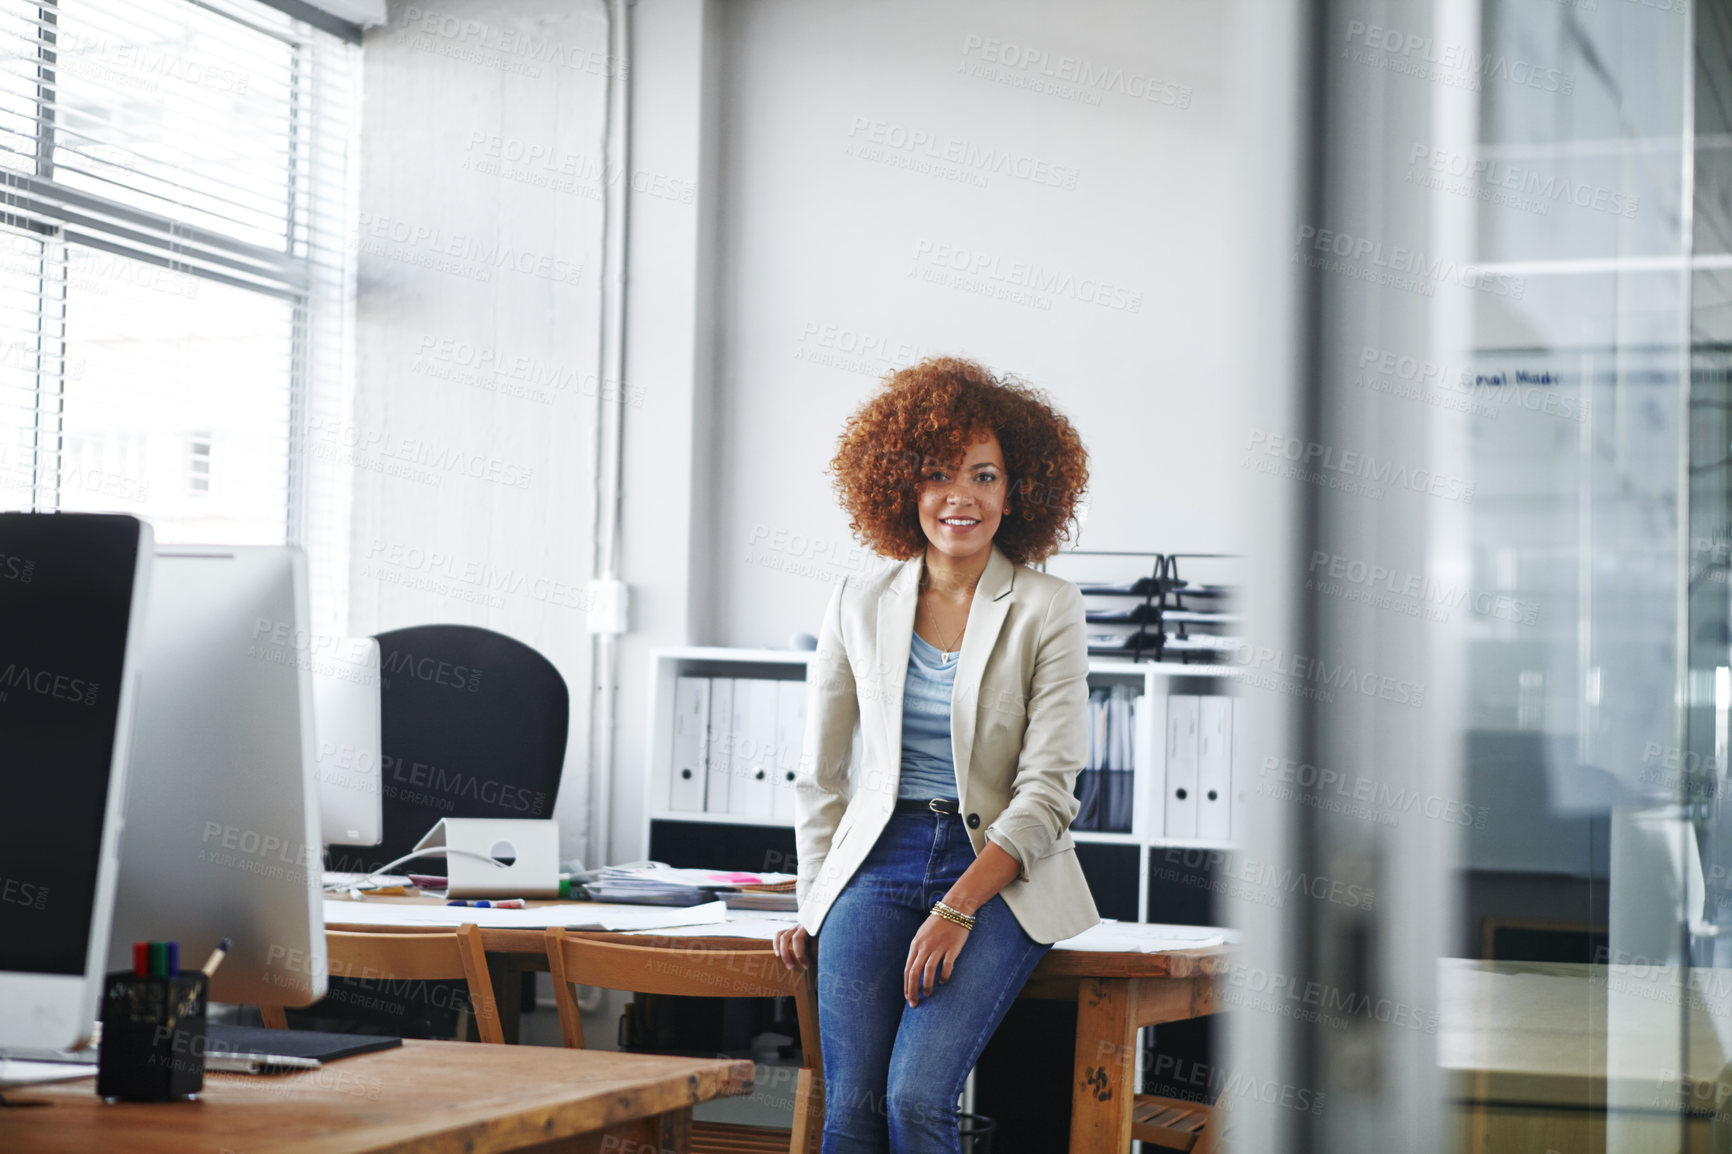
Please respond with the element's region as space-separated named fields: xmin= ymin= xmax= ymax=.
xmin=1070 ymin=977 xmax=1136 ymax=1154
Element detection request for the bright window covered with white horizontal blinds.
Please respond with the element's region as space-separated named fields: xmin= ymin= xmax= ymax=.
xmin=0 ymin=0 xmax=360 ymax=631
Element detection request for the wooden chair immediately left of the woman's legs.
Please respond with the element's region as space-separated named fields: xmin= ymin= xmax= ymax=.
xmin=547 ymin=929 xmax=824 ymax=1154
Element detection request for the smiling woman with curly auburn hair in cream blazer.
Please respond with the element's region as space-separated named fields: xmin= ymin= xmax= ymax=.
xmin=776 ymin=357 xmax=1100 ymax=1154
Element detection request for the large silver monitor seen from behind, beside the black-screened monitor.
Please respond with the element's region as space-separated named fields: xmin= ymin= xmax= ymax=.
xmin=109 ymin=546 xmax=326 ymax=1005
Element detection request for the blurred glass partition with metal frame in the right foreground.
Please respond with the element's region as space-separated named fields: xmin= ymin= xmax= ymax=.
xmin=1233 ymin=0 xmax=1732 ymax=1154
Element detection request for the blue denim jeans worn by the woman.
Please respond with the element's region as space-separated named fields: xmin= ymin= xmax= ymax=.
xmin=816 ymin=813 xmax=1051 ymax=1154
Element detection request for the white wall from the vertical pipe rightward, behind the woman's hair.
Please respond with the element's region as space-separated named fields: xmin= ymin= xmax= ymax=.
xmin=610 ymin=0 xmax=1249 ymax=859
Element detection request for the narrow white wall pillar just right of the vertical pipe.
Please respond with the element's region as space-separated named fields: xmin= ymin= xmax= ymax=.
xmin=608 ymin=0 xmax=717 ymax=861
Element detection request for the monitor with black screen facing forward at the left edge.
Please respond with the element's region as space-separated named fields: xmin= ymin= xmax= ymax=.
xmin=0 ymin=513 xmax=151 ymax=1050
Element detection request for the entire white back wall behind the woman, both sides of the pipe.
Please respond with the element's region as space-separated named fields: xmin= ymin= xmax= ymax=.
xmin=343 ymin=0 xmax=1256 ymax=861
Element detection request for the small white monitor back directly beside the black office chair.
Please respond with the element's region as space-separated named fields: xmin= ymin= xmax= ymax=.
xmin=313 ymin=638 xmax=385 ymax=846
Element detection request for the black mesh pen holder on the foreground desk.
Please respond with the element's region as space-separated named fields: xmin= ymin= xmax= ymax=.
xmin=97 ymin=970 xmax=210 ymax=1102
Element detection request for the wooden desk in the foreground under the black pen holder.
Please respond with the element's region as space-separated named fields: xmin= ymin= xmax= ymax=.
xmin=0 ymin=1041 xmax=752 ymax=1154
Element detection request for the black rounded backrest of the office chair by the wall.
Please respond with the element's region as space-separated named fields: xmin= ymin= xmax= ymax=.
xmin=372 ymin=626 xmax=572 ymax=873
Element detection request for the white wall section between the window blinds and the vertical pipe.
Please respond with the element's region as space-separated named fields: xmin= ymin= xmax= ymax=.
xmin=353 ymin=0 xmax=613 ymax=854
